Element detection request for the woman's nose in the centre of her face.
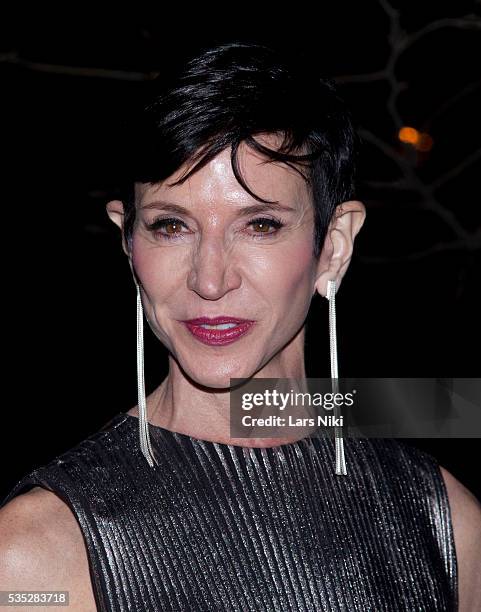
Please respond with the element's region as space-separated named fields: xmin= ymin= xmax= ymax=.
xmin=187 ymin=235 xmax=242 ymax=300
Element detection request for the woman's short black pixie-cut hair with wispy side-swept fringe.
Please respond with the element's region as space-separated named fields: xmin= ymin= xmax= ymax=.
xmin=118 ymin=42 xmax=359 ymax=259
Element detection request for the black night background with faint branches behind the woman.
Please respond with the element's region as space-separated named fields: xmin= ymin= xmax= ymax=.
xmin=0 ymin=0 xmax=481 ymax=497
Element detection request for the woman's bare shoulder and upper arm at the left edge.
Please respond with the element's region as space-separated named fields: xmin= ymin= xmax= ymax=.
xmin=0 ymin=487 xmax=97 ymax=611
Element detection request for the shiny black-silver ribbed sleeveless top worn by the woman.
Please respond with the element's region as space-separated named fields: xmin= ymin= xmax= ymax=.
xmin=2 ymin=413 xmax=458 ymax=612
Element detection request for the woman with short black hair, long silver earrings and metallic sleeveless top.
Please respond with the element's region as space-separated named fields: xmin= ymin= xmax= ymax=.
xmin=0 ymin=43 xmax=481 ymax=612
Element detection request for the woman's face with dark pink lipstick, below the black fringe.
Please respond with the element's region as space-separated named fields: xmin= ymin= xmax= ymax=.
xmin=131 ymin=135 xmax=317 ymax=388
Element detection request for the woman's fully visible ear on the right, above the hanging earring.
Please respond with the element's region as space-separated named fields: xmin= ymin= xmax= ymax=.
xmin=315 ymin=200 xmax=366 ymax=297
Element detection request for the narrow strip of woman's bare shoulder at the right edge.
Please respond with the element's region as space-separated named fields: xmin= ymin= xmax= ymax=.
xmin=440 ymin=466 xmax=481 ymax=612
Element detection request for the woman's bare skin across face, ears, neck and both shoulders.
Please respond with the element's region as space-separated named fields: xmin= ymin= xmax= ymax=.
xmin=0 ymin=137 xmax=481 ymax=612
